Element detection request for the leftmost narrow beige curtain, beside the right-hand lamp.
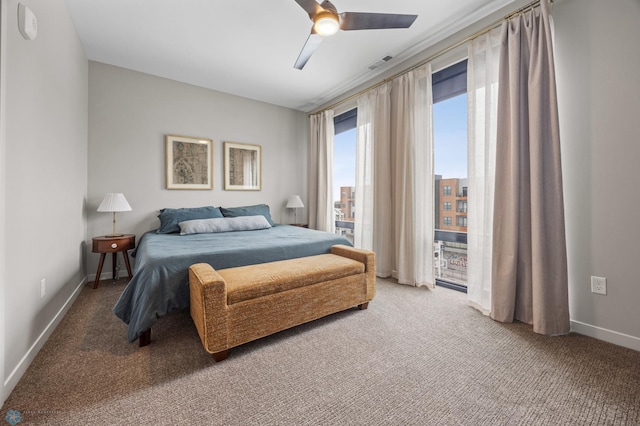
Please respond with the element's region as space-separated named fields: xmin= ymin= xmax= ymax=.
xmin=308 ymin=110 xmax=335 ymax=232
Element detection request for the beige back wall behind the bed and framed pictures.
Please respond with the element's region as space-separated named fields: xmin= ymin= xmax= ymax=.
xmin=86 ymin=62 xmax=309 ymax=279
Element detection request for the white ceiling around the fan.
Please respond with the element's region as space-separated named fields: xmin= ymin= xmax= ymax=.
xmin=65 ymin=0 xmax=514 ymax=112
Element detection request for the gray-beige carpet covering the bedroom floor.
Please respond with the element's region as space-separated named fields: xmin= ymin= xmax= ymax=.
xmin=0 ymin=280 xmax=640 ymax=425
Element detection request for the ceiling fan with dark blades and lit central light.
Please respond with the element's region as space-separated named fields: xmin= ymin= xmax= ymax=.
xmin=294 ymin=0 xmax=418 ymax=70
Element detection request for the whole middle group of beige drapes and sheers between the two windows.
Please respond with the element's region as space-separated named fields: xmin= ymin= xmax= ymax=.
xmin=355 ymin=64 xmax=435 ymax=287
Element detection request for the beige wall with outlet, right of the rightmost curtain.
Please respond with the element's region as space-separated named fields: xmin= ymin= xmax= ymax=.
xmin=553 ymin=0 xmax=640 ymax=350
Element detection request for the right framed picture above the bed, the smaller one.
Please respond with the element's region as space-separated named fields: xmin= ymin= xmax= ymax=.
xmin=224 ymin=142 xmax=262 ymax=191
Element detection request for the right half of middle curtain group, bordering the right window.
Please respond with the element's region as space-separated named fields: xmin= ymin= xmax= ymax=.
xmin=391 ymin=64 xmax=435 ymax=287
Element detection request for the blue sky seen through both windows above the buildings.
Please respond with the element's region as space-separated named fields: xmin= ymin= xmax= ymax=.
xmin=333 ymin=94 xmax=467 ymax=201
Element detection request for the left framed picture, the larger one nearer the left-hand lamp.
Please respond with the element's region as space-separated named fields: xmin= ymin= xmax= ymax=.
xmin=166 ymin=135 xmax=213 ymax=189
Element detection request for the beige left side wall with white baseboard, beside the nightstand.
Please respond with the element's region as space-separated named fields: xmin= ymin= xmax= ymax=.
xmin=0 ymin=0 xmax=88 ymax=398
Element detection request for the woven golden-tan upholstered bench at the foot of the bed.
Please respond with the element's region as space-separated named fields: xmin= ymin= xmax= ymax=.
xmin=189 ymin=245 xmax=376 ymax=361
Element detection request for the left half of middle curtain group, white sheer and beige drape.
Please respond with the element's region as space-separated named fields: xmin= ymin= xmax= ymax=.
xmin=354 ymin=83 xmax=394 ymax=277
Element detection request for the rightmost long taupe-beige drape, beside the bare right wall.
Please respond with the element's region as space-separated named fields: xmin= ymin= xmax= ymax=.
xmin=491 ymin=0 xmax=570 ymax=335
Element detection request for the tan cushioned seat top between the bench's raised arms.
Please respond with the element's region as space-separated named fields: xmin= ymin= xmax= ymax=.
xmin=217 ymin=254 xmax=365 ymax=305
